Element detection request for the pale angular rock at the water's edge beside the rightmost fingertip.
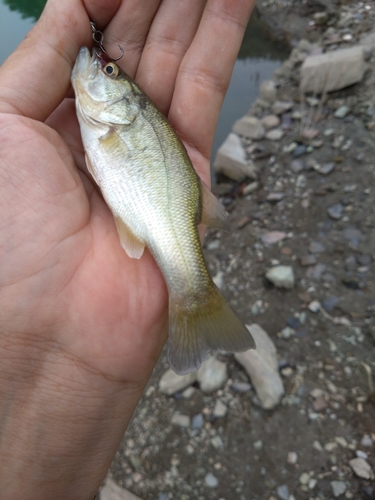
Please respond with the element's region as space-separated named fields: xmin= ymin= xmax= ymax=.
xmin=213 ymin=134 xmax=257 ymax=182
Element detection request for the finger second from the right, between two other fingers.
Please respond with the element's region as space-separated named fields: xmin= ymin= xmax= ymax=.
xmin=136 ymin=0 xmax=206 ymax=114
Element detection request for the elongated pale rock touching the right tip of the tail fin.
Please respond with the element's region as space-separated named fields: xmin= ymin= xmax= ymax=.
xmin=234 ymin=324 xmax=284 ymax=410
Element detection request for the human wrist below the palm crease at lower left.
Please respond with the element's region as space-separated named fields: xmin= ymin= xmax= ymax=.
xmin=0 ymin=342 xmax=141 ymax=500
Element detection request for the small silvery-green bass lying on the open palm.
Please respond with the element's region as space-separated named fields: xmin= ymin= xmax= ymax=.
xmin=72 ymin=47 xmax=254 ymax=374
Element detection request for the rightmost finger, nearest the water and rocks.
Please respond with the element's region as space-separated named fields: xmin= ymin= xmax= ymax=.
xmin=169 ymin=0 xmax=255 ymax=158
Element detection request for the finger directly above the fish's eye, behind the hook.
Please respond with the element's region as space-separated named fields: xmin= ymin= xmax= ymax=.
xmin=101 ymin=0 xmax=161 ymax=78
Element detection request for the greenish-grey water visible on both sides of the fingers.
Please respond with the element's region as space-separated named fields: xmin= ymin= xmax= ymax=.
xmin=0 ymin=0 xmax=288 ymax=158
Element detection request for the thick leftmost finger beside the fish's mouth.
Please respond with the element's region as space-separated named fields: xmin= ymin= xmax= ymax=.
xmin=0 ymin=0 xmax=117 ymax=121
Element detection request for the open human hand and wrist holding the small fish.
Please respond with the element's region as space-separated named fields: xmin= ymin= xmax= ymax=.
xmin=0 ymin=0 xmax=254 ymax=500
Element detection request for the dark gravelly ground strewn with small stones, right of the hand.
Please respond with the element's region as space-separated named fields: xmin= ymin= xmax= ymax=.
xmin=102 ymin=0 xmax=375 ymax=500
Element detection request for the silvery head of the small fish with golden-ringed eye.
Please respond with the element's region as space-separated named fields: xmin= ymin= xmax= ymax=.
xmin=71 ymin=47 xmax=142 ymax=126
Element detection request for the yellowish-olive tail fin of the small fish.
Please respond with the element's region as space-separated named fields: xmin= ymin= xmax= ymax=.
xmin=168 ymin=286 xmax=255 ymax=375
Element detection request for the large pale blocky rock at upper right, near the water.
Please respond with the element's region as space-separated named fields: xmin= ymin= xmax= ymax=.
xmin=300 ymin=47 xmax=367 ymax=94
